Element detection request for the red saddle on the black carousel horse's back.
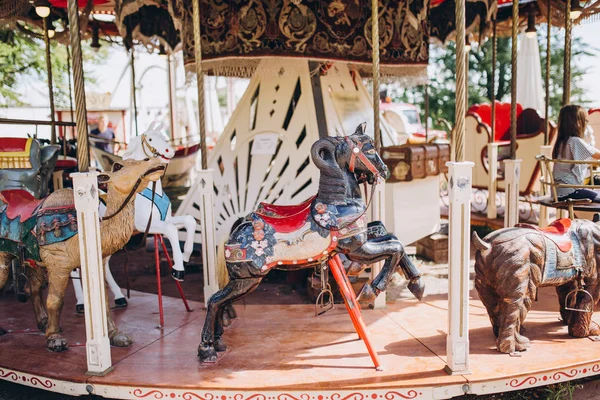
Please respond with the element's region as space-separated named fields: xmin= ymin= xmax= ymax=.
xmin=256 ymin=196 xmax=316 ymax=233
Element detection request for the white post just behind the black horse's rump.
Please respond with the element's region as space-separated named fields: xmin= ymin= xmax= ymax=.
xmin=197 ymin=169 xmax=219 ymax=306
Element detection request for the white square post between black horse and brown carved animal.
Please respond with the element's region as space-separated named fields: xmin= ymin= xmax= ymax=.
xmin=445 ymin=161 xmax=474 ymax=375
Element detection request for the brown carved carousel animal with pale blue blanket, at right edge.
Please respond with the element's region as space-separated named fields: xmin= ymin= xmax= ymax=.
xmin=472 ymin=219 xmax=600 ymax=353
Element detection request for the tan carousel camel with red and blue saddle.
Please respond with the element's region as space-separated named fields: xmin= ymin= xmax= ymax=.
xmin=0 ymin=158 xmax=165 ymax=351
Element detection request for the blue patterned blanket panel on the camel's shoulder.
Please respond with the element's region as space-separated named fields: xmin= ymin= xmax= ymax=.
xmin=36 ymin=205 xmax=77 ymax=246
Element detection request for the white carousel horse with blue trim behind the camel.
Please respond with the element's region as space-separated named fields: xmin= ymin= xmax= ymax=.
xmin=71 ymin=122 xmax=196 ymax=312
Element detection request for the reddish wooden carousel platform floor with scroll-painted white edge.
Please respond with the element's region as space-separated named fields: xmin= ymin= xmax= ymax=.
xmin=0 ymin=289 xmax=600 ymax=400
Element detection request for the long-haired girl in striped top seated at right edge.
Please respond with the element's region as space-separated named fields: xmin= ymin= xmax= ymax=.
xmin=552 ymin=105 xmax=600 ymax=203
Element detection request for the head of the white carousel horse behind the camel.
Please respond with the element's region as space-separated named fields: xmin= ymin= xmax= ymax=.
xmin=123 ymin=122 xmax=175 ymax=163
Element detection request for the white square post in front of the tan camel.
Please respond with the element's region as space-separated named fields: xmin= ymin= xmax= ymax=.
xmin=71 ymin=172 xmax=112 ymax=375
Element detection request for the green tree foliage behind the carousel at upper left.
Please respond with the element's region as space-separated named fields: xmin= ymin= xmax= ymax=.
xmin=0 ymin=25 xmax=108 ymax=107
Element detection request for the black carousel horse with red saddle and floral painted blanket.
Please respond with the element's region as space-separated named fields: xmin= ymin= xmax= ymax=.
xmin=198 ymin=124 xmax=424 ymax=366
